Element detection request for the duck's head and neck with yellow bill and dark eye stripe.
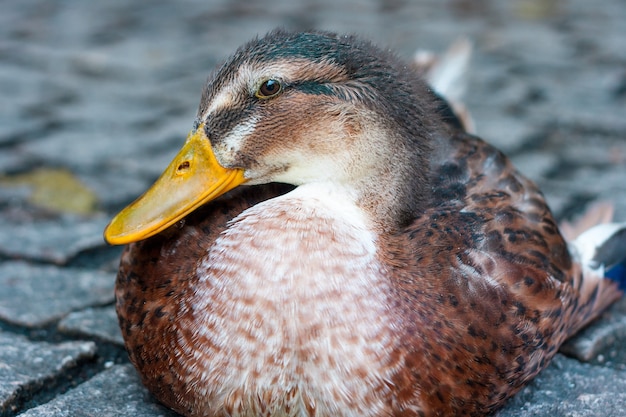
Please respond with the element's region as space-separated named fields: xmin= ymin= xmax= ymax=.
xmin=105 ymin=31 xmax=440 ymax=244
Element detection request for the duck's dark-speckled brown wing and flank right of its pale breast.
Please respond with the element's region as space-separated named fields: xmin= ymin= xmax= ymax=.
xmin=388 ymin=133 xmax=619 ymax=415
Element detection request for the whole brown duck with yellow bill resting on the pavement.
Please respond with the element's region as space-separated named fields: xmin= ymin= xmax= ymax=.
xmin=104 ymin=29 xmax=626 ymax=417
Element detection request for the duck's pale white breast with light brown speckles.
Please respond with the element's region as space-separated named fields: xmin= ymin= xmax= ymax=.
xmin=179 ymin=186 xmax=394 ymax=416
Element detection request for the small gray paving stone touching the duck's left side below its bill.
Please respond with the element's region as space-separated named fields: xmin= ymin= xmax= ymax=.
xmin=58 ymin=306 xmax=124 ymax=346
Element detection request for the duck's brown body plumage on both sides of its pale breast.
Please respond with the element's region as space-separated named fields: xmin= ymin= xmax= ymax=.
xmin=116 ymin=134 xmax=618 ymax=416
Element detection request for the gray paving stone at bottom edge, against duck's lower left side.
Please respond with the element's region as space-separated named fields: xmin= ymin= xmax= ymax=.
xmin=20 ymin=365 xmax=178 ymax=417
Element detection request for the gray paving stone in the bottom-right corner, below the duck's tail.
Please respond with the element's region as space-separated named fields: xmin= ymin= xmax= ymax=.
xmin=494 ymin=355 xmax=626 ymax=417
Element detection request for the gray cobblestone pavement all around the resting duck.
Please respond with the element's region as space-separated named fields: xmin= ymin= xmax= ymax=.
xmin=0 ymin=0 xmax=626 ymax=417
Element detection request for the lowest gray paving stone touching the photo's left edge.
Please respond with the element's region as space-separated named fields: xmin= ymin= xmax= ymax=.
xmin=0 ymin=332 xmax=96 ymax=415
